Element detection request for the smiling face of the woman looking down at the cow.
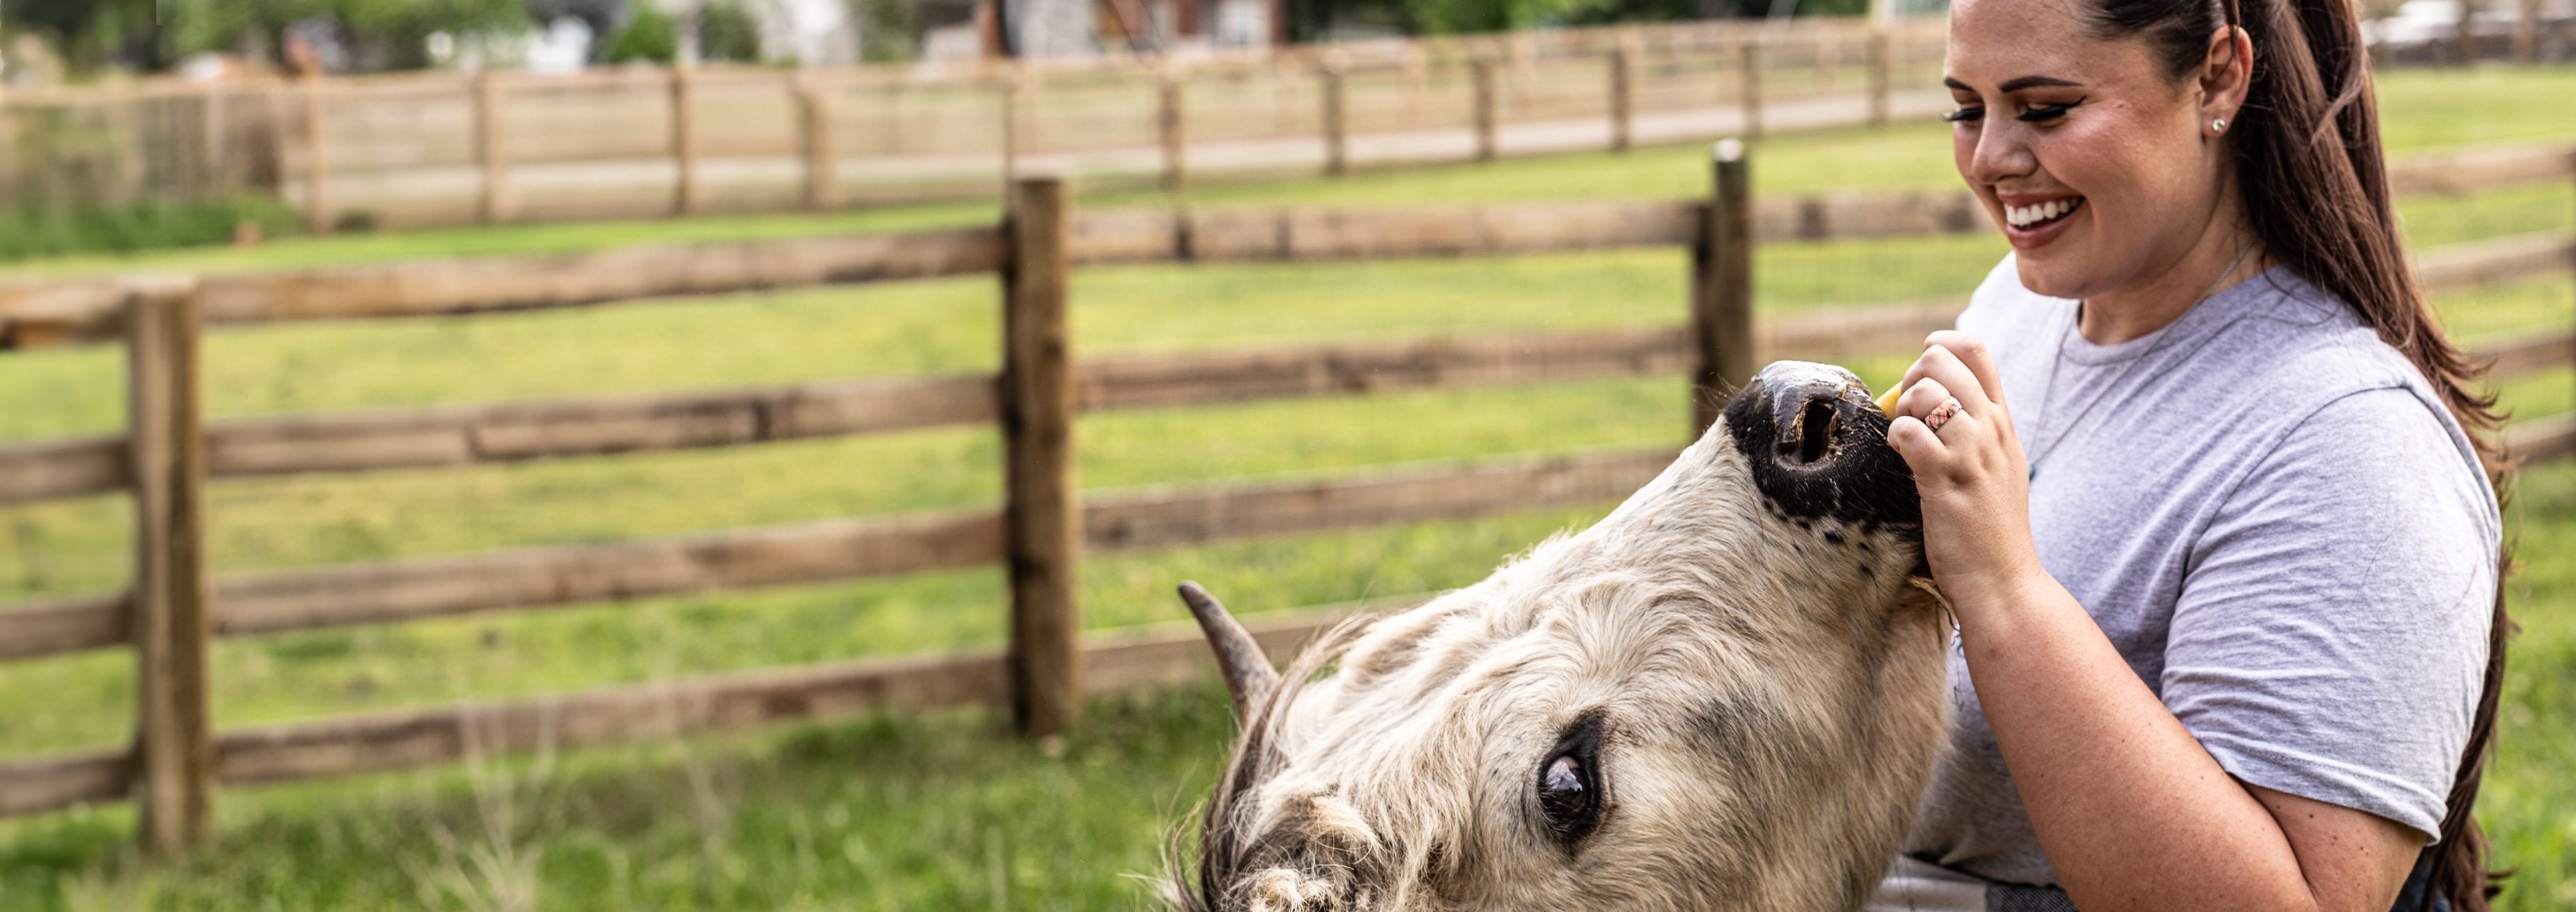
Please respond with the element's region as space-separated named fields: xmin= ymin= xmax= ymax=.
xmin=1942 ymin=0 xmax=2233 ymax=299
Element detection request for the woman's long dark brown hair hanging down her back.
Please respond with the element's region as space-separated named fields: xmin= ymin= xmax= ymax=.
xmin=2089 ymin=0 xmax=2511 ymax=912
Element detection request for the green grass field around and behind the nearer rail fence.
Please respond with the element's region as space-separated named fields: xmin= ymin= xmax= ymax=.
xmin=0 ymin=70 xmax=2576 ymax=909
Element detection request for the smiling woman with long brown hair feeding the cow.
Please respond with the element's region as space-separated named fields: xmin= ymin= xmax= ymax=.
xmin=1873 ymin=0 xmax=2504 ymax=912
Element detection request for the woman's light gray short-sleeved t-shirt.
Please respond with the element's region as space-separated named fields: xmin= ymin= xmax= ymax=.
xmin=1904 ymin=258 xmax=2502 ymax=883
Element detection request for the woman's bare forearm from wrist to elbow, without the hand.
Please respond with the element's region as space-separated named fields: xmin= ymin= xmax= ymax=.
xmin=1955 ymin=574 xmax=2331 ymax=912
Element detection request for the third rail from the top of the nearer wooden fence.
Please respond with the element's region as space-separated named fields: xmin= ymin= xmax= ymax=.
xmin=0 ymin=440 xmax=1672 ymax=660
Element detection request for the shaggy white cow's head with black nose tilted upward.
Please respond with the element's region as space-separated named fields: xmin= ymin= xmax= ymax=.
xmin=1172 ymin=364 xmax=1948 ymax=912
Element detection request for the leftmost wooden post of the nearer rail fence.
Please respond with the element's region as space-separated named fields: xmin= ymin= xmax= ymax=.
xmin=127 ymin=286 xmax=214 ymax=853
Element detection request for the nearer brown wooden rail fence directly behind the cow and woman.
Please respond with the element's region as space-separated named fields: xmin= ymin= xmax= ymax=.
xmin=0 ymin=147 xmax=2576 ymax=847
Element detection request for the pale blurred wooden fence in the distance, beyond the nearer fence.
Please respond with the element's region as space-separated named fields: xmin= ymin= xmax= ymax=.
xmin=0 ymin=18 xmax=1948 ymax=229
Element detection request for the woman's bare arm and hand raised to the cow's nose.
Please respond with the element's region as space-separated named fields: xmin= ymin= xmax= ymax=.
xmin=1888 ymin=332 xmax=2424 ymax=912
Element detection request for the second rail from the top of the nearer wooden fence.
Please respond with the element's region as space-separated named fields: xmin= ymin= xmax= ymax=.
xmin=0 ymin=304 xmax=1958 ymax=503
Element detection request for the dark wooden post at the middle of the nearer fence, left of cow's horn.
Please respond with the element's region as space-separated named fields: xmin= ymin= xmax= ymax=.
xmin=1002 ymin=175 xmax=1082 ymax=737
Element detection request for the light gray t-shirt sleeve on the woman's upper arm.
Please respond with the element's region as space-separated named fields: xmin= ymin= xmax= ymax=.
xmin=2161 ymin=386 xmax=2499 ymax=840
